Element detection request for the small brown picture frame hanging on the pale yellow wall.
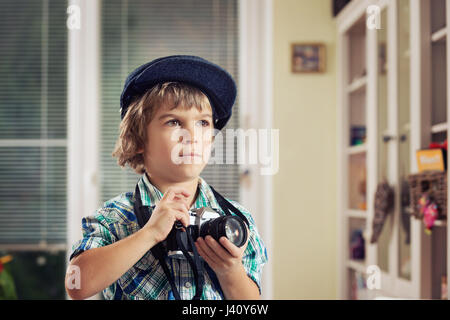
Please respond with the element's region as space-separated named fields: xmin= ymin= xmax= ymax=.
xmin=291 ymin=43 xmax=325 ymax=73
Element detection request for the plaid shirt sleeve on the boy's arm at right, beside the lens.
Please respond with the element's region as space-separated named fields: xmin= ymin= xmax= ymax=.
xmin=227 ymin=199 xmax=268 ymax=294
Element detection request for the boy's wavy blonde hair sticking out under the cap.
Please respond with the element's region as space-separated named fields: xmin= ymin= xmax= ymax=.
xmin=112 ymin=82 xmax=214 ymax=174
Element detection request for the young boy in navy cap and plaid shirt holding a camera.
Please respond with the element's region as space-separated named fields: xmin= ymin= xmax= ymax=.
xmin=66 ymin=56 xmax=267 ymax=300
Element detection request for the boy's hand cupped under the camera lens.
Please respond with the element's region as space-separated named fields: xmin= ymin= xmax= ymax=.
xmin=195 ymin=228 xmax=250 ymax=278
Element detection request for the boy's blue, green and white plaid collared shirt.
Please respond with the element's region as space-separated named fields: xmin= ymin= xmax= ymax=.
xmin=70 ymin=174 xmax=268 ymax=300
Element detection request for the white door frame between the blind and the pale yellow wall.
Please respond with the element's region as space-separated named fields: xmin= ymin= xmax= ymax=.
xmin=239 ymin=0 xmax=278 ymax=299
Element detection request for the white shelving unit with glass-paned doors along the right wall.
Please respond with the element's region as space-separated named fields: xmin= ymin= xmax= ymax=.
xmin=337 ymin=0 xmax=450 ymax=299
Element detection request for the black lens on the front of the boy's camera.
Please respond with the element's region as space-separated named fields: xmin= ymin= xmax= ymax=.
xmin=200 ymin=216 xmax=247 ymax=247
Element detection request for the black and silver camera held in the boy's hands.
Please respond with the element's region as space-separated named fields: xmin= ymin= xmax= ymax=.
xmin=164 ymin=207 xmax=247 ymax=259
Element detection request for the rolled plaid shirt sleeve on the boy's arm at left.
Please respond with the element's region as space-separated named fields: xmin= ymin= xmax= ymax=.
xmin=69 ymin=208 xmax=117 ymax=260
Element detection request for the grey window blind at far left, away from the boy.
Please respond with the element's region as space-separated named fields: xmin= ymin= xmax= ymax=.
xmin=0 ymin=0 xmax=67 ymax=247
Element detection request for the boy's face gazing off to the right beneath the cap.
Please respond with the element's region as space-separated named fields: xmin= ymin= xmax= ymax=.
xmin=144 ymin=102 xmax=214 ymax=182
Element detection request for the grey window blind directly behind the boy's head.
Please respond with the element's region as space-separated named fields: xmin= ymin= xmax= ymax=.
xmin=100 ymin=0 xmax=239 ymax=202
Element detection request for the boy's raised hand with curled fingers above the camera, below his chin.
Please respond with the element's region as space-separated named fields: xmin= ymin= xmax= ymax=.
xmin=144 ymin=187 xmax=190 ymax=242
